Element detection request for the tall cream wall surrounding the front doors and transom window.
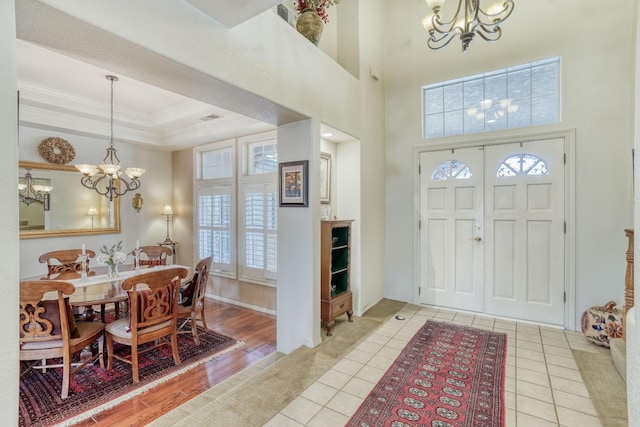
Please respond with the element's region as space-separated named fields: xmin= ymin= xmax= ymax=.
xmin=385 ymin=0 xmax=635 ymax=325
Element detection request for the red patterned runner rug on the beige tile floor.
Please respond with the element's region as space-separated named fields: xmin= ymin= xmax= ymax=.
xmin=347 ymin=320 xmax=507 ymax=427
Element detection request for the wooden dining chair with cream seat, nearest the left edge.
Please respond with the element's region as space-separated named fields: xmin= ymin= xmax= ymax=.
xmin=19 ymin=280 xmax=104 ymax=399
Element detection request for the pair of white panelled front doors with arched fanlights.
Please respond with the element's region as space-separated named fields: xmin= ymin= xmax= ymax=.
xmin=419 ymin=138 xmax=565 ymax=325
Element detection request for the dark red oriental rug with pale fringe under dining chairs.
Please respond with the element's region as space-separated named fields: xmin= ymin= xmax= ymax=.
xmin=19 ymin=327 xmax=243 ymax=427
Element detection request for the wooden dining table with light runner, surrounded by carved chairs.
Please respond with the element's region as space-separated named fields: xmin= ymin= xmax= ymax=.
xmin=22 ymin=264 xmax=193 ymax=323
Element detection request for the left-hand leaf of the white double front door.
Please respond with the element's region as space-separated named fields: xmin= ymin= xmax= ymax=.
xmin=420 ymin=148 xmax=483 ymax=311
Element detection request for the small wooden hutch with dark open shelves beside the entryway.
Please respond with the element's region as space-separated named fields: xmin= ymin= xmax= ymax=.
xmin=320 ymin=220 xmax=353 ymax=336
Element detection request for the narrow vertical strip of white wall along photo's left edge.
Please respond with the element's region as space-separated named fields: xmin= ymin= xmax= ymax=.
xmin=0 ymin=1 xmax=19 ymax=425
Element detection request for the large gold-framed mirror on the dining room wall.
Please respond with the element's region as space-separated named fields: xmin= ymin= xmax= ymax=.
xmin=18 ymin=161 xmax=120 ymax=239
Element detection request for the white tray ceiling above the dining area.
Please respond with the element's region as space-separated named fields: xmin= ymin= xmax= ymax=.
xmin=17 ymin=40 xmax=274 ymax=150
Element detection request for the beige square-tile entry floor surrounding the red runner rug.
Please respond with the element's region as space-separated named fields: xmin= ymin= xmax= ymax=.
xmin=266 ymin=305 xmax=601 ymax=427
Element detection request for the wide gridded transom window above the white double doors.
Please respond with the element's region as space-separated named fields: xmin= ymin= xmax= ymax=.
xmin=422 ymin=57 xmax=560 ymax=138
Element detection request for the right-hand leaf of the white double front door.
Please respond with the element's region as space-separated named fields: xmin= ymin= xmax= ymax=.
xmin=485 ymin=139 xmax=565 ymax=325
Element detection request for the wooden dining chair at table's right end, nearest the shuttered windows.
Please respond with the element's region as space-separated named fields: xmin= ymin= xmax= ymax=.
xmin=178 ymin=257 xmax=213 ymax=345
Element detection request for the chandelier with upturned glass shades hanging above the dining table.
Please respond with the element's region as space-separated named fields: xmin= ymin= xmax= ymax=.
xmin=76 ymin=76 xmax=145 ymax=201
